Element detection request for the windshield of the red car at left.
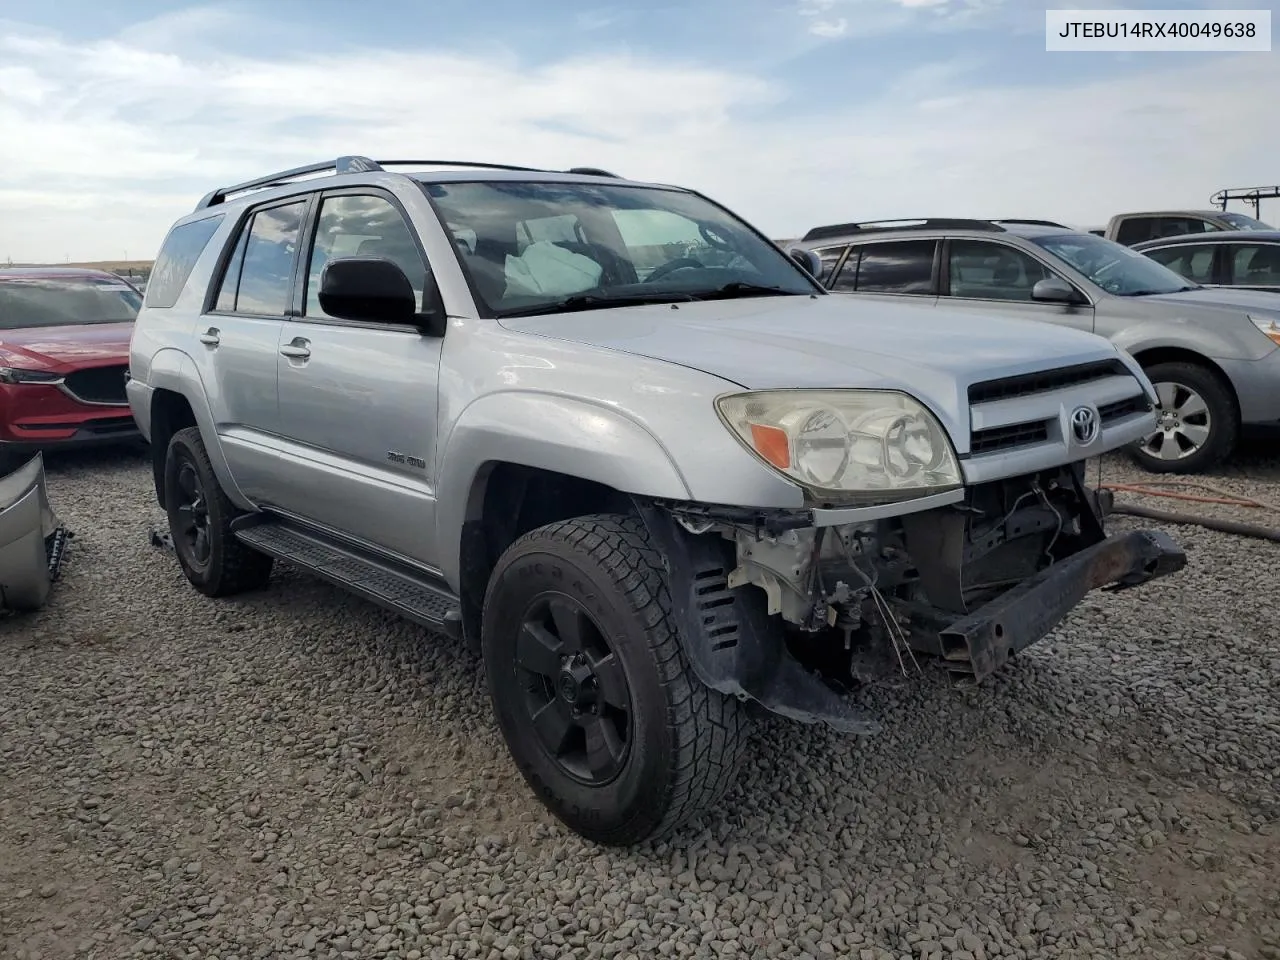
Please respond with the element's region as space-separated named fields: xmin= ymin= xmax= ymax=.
xmin=0 ymin=276 xmax=142 ymax=330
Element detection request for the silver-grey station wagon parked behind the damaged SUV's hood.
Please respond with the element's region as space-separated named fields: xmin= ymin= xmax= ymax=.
xmin=797 ymin=219 xmax=1280 ymax=474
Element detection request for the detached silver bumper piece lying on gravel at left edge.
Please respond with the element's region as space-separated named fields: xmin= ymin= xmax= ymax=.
xmin=0 ymin=453 xmax=69 ymax=612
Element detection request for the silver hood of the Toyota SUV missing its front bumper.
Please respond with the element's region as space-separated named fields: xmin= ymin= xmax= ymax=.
xmin=500 ymin=294 xmax=1119 ymax=425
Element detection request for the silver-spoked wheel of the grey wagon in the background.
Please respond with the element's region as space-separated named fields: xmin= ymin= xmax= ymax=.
xmin=1133 ymin=362 xmax=1240 ymax=474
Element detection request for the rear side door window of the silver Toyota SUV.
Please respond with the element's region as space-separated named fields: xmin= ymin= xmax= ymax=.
xmin=216 ymin=200 xmax=306 ymax=316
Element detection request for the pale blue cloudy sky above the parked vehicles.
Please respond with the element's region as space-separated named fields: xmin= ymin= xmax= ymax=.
xmin=0 ymin=0 xmax=1280 ymax=262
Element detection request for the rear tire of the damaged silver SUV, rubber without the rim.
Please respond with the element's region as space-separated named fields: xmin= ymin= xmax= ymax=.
xmin=164 ymin=426 xmax=271 ymax=596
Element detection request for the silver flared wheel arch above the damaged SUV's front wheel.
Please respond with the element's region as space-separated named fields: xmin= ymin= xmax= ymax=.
xmin=436 ymin=390 xmax=690 ymax=589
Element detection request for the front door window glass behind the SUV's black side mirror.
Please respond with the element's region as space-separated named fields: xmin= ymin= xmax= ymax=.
xmin=306 ymin=195 xmax=428 ymax=316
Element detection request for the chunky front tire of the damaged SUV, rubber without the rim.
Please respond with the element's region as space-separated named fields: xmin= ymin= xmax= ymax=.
xmin=481 ymin=515 xmax=750 ymax=846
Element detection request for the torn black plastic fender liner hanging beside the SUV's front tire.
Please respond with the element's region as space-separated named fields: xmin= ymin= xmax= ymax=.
xmin=636 ymin=498 xmax=881 ymax=735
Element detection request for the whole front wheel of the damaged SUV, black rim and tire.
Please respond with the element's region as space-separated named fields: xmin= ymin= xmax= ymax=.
xmin=480 ymin=513 xmax=750 ymax=846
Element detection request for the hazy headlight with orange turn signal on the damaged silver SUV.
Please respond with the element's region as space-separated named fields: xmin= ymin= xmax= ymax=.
xmin=716 ymin=390 xmax=963 ymax=503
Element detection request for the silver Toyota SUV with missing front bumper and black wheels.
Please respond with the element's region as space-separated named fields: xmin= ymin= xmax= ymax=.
xmin=128 ymin=157 xmax=1184 ymax=845
